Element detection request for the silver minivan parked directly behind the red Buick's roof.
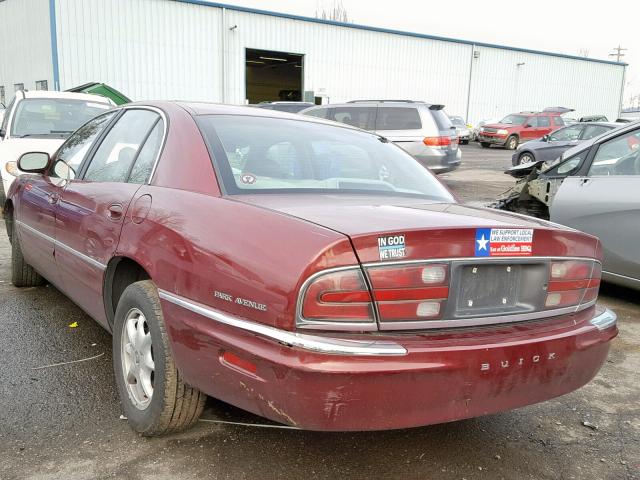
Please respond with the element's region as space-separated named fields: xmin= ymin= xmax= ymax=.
xmin=300 ymin=100 xmax=462 ymax=173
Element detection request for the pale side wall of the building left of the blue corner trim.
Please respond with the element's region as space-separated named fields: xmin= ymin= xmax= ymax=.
xmin=0 ymin=0 xmax=53 ymax=103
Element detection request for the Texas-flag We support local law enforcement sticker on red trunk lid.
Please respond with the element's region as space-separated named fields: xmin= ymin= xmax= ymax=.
xmin=475 ymin=228 xmax=533 ymax=257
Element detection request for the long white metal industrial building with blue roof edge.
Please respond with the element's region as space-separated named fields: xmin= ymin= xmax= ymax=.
xmin=0 ymin=0 xmax=625 ymax=122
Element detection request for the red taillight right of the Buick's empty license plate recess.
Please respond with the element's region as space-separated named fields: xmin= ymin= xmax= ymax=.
xmin=545 ymin=260 xmax=602 ymax=309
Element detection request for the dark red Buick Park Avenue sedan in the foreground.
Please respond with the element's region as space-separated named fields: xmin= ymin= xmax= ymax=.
xmin=5 ymin=102 xmax=617 ymax=435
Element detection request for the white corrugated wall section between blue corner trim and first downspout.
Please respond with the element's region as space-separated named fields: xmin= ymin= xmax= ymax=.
xmin=56 ymin=0 xmax=222 ymax=100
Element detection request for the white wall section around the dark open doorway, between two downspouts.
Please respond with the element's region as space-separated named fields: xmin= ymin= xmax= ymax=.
xmin=226 ymin=10 xmax=471 ymax=114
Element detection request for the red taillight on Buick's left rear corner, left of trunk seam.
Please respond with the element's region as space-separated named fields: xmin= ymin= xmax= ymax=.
xmin=300 ymin=268 xmax=376 ymax=329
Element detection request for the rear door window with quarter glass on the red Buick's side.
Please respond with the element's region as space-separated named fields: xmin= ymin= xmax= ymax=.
xmin=84 ymin=109 xmax=159 ymax=182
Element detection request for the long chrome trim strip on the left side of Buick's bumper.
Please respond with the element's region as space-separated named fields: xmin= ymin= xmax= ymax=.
xmin=158 ymin=290 xmax=407 ymax=356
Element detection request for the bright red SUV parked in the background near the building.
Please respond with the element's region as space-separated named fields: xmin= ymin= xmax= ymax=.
xmin=478 ymin=111 xmax=565 ymax=150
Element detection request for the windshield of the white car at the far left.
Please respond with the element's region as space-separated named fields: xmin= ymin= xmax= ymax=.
xmin=11 ymin=98 xmax=111 ymax=138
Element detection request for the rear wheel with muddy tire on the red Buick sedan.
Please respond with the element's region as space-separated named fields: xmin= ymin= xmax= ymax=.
xmin=113 ymin=280 xmax=206 ymax=436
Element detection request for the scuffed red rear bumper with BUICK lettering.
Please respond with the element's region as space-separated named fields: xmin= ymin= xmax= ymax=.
xmin=162 ymin=296 xmax=617 ymax=431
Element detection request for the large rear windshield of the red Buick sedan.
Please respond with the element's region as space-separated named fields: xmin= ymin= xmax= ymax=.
xmin=197 ymin=115 xmax=453 ymax=202
